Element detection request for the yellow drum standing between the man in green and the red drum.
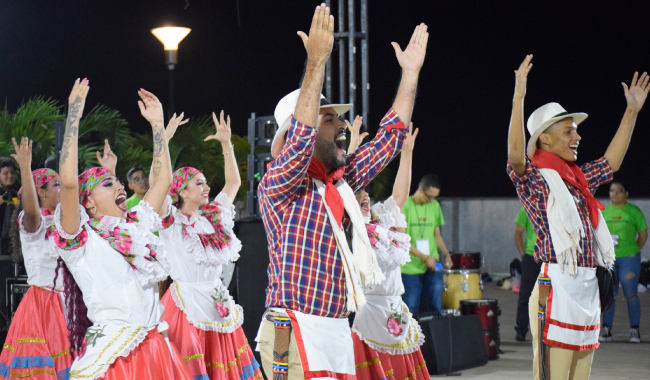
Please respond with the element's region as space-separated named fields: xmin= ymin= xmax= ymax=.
xmin=442 ymin=269 xmax=483 ymax=309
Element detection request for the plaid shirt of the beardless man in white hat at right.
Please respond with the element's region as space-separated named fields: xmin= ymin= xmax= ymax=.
xmin=506 ymin=157 xmax=614 ymax=268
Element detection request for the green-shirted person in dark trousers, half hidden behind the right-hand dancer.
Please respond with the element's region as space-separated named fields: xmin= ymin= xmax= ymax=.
xmin=515 ymin=207 xmax=542 ymax=342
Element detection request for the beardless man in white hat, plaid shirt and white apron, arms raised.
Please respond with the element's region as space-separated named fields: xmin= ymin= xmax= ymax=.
xmin=507 ymin=55 xmax=650 ymax=380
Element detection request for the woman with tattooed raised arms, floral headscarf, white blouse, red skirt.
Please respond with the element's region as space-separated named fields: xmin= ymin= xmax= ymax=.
xmin=52 ymin=79 xmax=192 ymax=380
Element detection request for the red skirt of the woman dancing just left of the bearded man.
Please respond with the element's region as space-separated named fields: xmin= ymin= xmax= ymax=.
xmin=161 ymin=291 xmax=260 ymax=380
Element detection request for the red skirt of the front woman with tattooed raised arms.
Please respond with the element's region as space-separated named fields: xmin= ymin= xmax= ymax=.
xmin=104 ymin=329 xmax=194 ymax=380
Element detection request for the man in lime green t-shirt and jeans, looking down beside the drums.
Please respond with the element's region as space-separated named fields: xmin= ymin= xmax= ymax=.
xmin=401 ymin=174 xmax=452 ymax=313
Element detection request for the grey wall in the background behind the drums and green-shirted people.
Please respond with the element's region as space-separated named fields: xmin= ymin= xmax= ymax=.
xmin=440 ymin=198 xmax=650 ymax=273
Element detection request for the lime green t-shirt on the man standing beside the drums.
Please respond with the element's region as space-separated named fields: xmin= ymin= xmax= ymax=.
xmin=402 ymin=197 xmax=445 ymax=274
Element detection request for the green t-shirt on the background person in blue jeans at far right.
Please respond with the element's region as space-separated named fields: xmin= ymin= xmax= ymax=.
xmin=603 ymin=203 xmax=648 ymax=257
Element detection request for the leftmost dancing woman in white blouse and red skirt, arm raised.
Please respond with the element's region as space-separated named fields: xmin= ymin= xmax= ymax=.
xmin=0 ymin=137 xmax=72 ymax=380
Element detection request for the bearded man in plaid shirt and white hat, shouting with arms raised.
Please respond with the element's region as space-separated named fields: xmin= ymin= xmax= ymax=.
xmin=256 ymin=3 xmax=428 ymax=380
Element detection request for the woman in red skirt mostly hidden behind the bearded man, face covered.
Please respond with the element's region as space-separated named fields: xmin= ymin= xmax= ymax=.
xmin=348 ymin=120 xmax=429 ymax=380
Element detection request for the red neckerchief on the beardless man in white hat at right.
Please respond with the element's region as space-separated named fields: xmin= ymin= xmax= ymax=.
xmin=531 ymin=149 xmax=605 ymax=229
